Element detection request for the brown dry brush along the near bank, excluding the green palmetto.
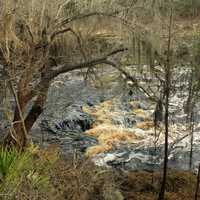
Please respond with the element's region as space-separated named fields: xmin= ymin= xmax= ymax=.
xmin=12 ymin=150 xmax=196 ymax=200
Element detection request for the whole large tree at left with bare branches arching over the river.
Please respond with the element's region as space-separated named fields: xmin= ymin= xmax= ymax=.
xmin=0 ymin=0 xmax=173 ymax=148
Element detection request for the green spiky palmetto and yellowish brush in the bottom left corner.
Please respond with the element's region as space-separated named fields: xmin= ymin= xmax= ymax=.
xmin=0 ymin=147 xmax=58 ymax=199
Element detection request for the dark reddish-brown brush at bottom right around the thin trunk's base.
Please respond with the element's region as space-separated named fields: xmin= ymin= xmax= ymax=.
xmin=120 ymin=171 xmax=196 ymax=200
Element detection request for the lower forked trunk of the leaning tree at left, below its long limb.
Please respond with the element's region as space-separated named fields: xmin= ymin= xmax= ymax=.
xmin=4 ymin=82 xmax=49 ymax=149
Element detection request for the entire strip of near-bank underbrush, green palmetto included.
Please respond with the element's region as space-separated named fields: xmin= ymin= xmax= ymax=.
xmin=0 ymin=146 xmax=196 ymax=200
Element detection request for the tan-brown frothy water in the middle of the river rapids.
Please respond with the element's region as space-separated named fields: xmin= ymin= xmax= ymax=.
xmin=84 ymin=99 xmax=148 ymax=157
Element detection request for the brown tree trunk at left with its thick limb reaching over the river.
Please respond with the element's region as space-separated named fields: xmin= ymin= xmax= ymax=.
xmin=4 ymin=48 xmax=127 ymax=149
